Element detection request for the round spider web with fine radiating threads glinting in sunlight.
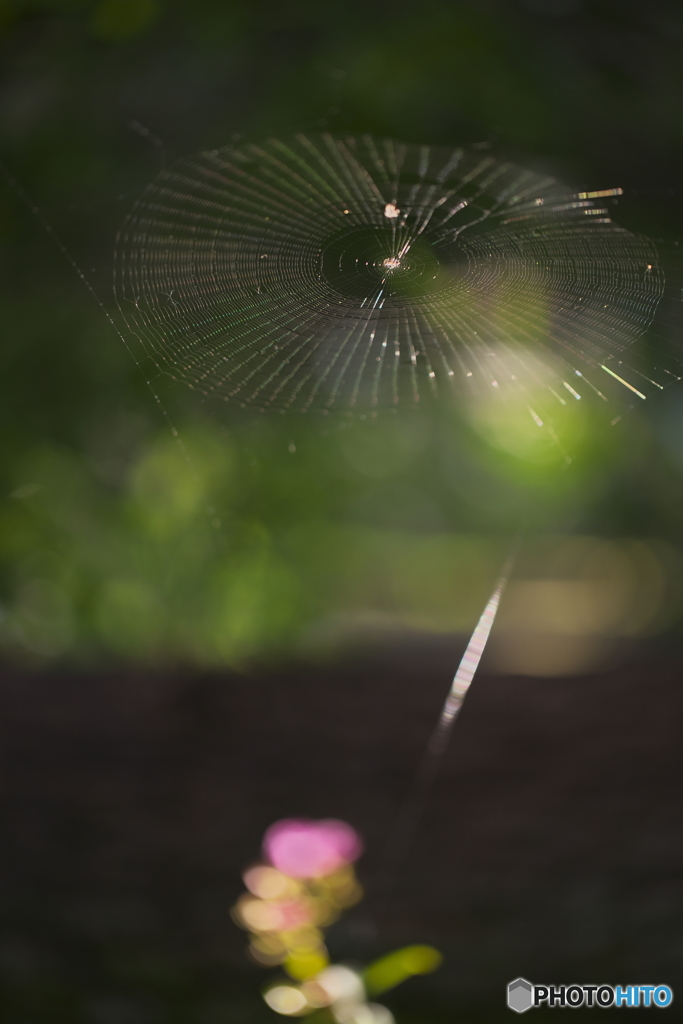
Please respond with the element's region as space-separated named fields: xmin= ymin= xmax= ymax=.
xmin=116 ymin=134 xmax=668 ymax=419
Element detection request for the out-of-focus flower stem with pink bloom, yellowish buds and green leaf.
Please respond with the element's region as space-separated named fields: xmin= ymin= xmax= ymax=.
xmin=233 ymin=819 xmax=441 ymax=1024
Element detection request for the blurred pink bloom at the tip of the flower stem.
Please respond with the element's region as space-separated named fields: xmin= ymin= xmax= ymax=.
xmin=263 ymin=818 xmax=362 ymax=879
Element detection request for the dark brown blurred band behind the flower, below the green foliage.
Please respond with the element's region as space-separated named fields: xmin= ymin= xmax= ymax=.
xmin=0 ymin=645 xmax=683 ymax=1024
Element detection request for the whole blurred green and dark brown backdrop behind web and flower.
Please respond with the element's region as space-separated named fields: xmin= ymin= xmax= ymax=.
xmin=0 ymin=0 xmax=683 ymax=1024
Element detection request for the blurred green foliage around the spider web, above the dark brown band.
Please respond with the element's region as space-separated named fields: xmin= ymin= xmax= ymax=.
xmin=0 ymin=0 xmax=683 ymax=666
